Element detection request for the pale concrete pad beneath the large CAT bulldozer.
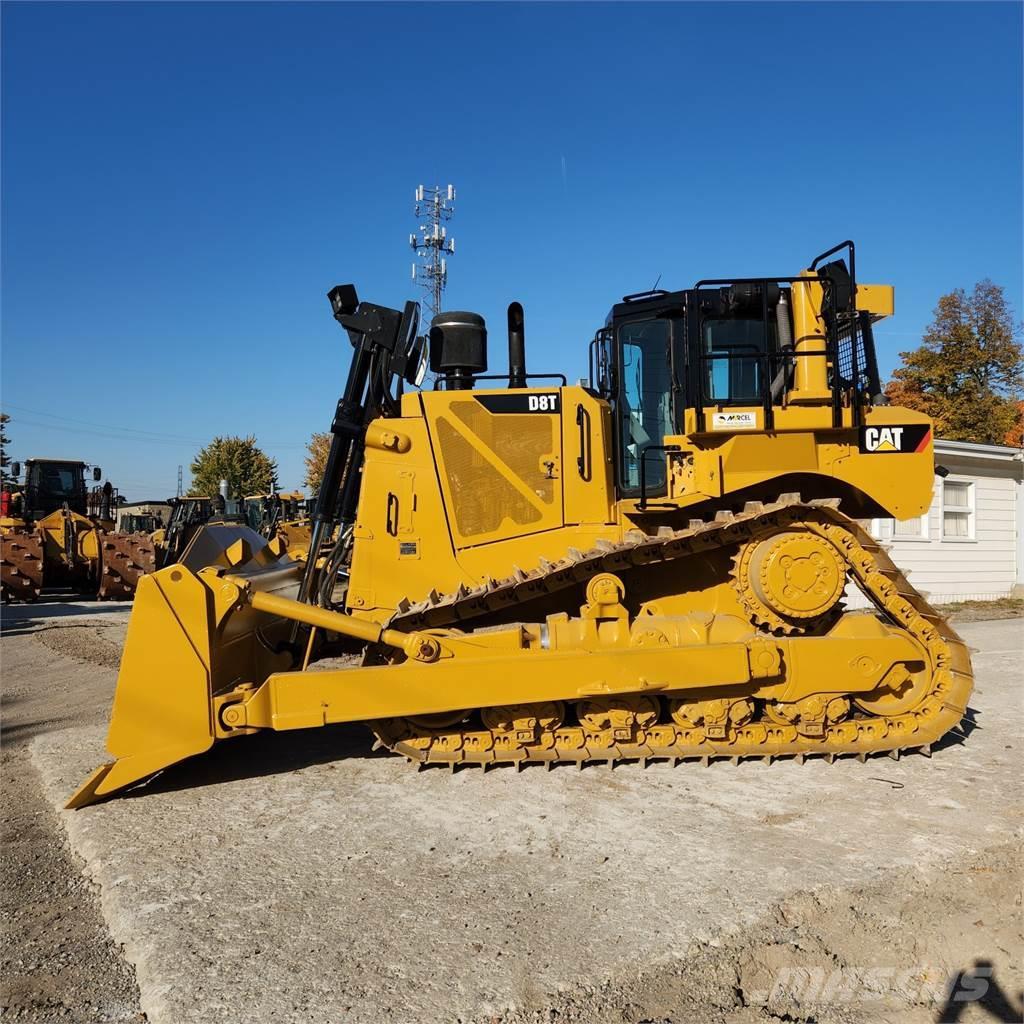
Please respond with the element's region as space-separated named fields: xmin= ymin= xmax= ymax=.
xmin=33 ymin=622 xmax=1024 ymax=1024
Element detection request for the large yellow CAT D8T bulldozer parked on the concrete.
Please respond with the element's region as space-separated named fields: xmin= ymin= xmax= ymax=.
xmin=69 ymin=242 xmax=972 ymax=807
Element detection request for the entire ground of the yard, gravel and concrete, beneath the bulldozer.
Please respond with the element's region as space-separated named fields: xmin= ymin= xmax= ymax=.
xmin=2 ymin=602 xmax=1024 ymax=1024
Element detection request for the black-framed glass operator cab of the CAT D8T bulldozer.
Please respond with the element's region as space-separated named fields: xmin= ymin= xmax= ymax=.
xmin=590 ymin=243 xmax=884 ymax=497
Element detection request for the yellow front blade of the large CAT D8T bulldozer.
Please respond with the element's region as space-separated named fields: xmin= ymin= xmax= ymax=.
xmin=67 ymin=525 xmax=299 ymax=808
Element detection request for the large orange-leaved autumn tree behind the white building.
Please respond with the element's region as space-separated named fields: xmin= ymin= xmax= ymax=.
xmin=886 ymin=279 xmax=1024 ymax=444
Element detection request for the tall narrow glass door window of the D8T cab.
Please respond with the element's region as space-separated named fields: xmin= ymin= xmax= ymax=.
xmin=617 ymin=319 xmax=675 ymax=494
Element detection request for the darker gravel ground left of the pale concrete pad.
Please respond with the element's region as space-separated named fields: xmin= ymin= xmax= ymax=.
xmin=0 ymin=602 xmax=145 ymax=1024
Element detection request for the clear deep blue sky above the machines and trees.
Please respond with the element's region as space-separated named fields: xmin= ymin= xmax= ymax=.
xmin=0 ymin=3 xmax=1024 ymax=498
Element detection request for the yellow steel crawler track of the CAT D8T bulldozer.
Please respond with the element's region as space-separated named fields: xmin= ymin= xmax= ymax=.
xmin=372 ymin=494 xmax=973 ymax=768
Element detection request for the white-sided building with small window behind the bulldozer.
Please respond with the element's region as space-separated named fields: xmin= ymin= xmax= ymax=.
xmin=864 ymin=440 xmax=1024 ymax=604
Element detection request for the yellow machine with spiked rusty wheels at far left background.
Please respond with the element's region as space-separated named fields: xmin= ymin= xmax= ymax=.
xmin=0 ymin=459 xmax=155 ymax=603
